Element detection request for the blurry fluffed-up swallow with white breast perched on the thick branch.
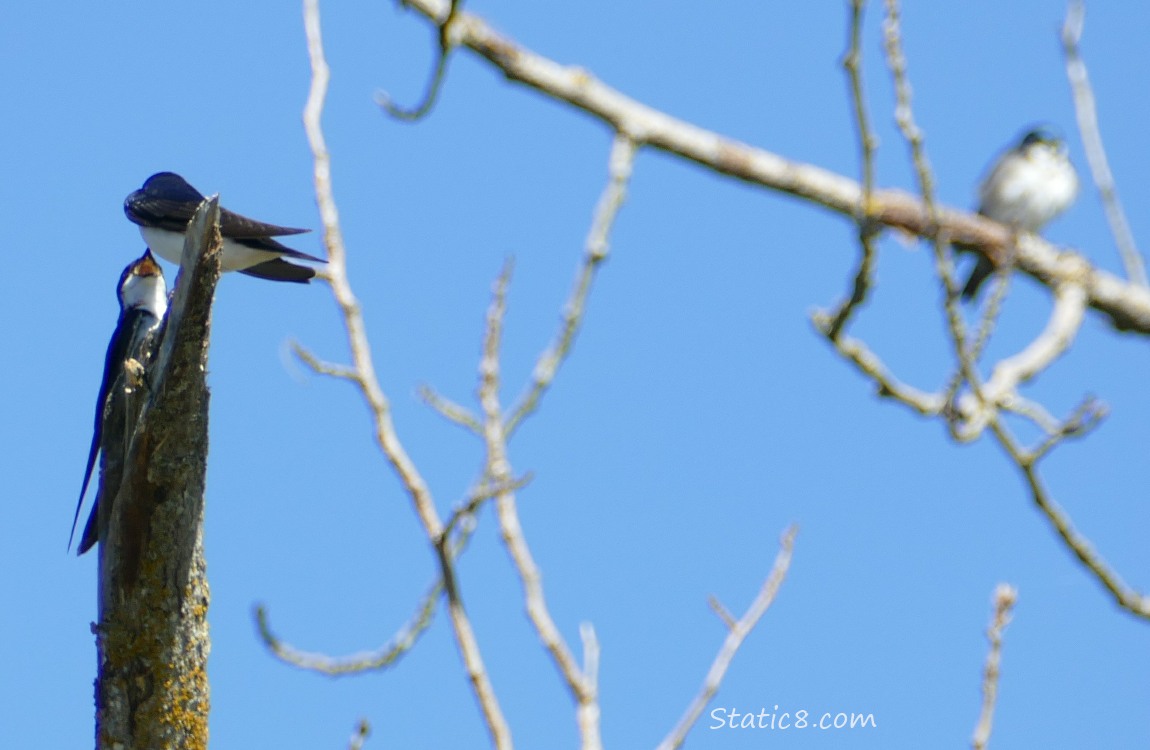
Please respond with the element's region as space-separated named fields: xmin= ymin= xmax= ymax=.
xmin=963 ymin=128 xmax=1078 ymax=300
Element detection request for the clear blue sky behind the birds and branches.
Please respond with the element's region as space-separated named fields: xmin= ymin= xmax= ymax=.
xmin=0 ymin=0 xmax=1150 ymax=750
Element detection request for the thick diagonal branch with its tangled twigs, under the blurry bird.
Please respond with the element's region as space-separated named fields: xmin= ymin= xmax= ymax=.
xmin=393 ymin=0 xmax=1150 ymax=625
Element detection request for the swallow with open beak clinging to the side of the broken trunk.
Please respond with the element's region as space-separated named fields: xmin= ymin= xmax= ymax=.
xmin=68 ymin=250 xmax=168 ymax=554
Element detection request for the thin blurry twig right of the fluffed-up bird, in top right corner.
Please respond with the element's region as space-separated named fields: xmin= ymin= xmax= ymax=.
xmin=1061 ymin=0 xmax=1147 ymax=286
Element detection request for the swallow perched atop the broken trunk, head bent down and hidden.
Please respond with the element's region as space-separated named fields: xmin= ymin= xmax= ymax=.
xmin=124 ymin=171 xmax=327 ymax=283
